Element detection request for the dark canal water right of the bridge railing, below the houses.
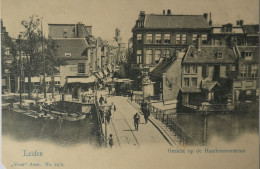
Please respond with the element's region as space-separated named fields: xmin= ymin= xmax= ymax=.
xmin=173 ymin=105 xmax=259 ymax=145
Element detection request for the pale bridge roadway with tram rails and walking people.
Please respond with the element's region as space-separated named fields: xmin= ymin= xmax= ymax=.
xmin=98 ymin=91 xmax=179 ymax=147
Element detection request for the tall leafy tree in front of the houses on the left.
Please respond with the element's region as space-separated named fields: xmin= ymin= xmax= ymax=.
xmin=17 ymin=15 xmax=61 ymax=98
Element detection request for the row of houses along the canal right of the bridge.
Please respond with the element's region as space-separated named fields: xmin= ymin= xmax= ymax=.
xmin=130 ymin=10 xmax=259 ymax=107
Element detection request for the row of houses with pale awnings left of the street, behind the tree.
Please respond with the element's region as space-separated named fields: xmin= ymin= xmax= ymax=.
xmin=1 ymin=22 xmax=126 ymax=97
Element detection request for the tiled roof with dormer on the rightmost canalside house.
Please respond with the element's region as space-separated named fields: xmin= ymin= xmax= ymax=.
xmin=237 ymin=46 xmax=259 ymax=63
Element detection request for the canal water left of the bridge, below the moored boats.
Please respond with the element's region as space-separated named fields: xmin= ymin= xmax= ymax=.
xmin=2 ymin=109 xmax=99 ymax=146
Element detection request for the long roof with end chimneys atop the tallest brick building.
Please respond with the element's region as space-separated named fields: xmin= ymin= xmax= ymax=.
xmin=144 ymin=14 xmax=210 ymax=29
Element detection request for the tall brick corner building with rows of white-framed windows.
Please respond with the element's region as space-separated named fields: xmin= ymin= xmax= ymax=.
xmin=131 ymin=10 xmax=212 ymax=73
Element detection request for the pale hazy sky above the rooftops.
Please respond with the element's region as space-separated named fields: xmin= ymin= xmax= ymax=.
xmin=1 ymin=0 xmax=259 ymax=42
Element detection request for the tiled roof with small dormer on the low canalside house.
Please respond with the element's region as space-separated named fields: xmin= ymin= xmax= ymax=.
xmin=183 ymin=46 xmax=236 ymax=63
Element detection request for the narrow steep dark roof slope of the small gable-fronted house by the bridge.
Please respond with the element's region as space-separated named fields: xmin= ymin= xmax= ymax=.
xmin=150 ymin=58 xmax=173 ymax=79
